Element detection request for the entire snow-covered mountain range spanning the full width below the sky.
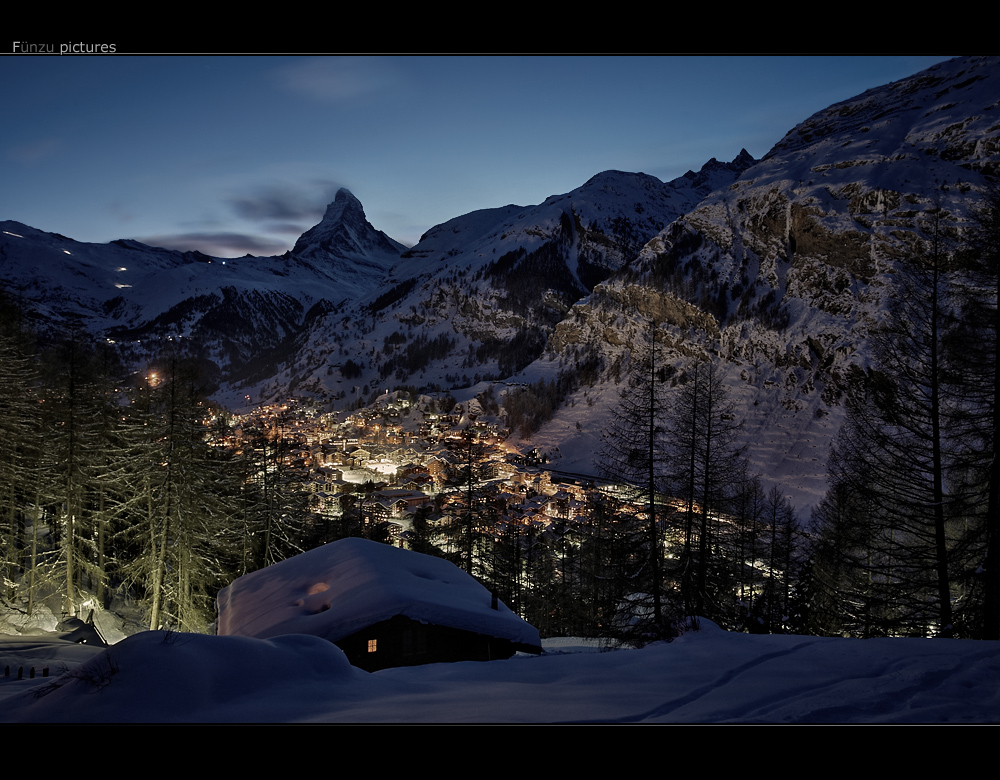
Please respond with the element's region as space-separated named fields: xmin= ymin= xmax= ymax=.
xmin=0 ymin=57 xmax=1000 ymax=503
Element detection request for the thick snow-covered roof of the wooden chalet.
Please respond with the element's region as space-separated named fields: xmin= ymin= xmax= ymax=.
xmin=219 ymin=539 xmax=541 ymax=647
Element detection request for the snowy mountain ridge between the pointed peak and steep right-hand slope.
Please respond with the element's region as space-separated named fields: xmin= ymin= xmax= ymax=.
xmin=261 ymin=156 xmax=753 ymax=406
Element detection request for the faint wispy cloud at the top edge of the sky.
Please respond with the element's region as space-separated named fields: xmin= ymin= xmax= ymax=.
xmin=272 ymin=57 xmax=400 ymax=102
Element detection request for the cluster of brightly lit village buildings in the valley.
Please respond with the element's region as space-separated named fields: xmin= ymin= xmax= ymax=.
xmin=216 ymin=391 xmax=590 ymax=547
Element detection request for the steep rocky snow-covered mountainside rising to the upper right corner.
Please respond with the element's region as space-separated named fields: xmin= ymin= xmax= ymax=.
xmin=543 ymin=58 xmax=1000 ymax=506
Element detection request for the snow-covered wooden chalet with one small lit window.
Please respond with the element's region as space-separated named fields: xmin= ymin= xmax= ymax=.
xmin=218 ymin=538 xmax=541 ymax=672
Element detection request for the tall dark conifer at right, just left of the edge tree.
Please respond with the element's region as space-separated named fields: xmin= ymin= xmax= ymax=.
xmin=820 ymin=212 xmax=965 ymax=636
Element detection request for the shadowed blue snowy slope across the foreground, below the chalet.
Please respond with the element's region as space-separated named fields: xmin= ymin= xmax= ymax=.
xmin=0 ymin=622 xmax=1000 ymax=723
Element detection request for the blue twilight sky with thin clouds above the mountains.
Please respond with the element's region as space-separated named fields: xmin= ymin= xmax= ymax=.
xmin=0 ymin=56 xmax=947 ymax=257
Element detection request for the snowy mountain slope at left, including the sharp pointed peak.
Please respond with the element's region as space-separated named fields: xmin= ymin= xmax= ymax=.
xmin=0 ymin=190 xmax=405 ymax=384
